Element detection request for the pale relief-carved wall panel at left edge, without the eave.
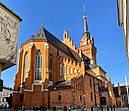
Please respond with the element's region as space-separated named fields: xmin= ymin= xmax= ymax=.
xmin=0 ymin=8 xmax=19 ymax=63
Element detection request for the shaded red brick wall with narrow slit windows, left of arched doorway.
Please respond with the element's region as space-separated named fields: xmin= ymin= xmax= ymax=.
xmin=83 ymin=73 xmax=102 ymax=107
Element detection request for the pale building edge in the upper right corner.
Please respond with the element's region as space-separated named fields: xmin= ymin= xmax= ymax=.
xmin=117 ymin=0 xmax=129 ymax=68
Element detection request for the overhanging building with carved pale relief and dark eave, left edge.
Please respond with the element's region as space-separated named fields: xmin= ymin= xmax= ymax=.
xmin=0 ymin=2 xmax=22 ymax=70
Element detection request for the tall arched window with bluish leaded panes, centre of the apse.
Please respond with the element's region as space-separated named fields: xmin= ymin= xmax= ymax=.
xmin=35 ymin=50 xmax=42 ymax=80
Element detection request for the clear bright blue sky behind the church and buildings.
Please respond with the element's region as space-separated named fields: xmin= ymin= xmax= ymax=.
xmin=1 ymin=0 xmax=129 ymax=87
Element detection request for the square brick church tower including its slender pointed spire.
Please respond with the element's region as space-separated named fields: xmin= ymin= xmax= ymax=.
xmin=79 ymin=7 xmax=96 ymax=64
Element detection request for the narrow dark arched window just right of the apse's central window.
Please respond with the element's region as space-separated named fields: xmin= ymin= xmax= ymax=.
xmin=49 ymin=54 xmax=53 ymax=81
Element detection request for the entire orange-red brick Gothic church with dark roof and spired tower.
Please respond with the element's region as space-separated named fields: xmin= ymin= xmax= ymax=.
xmin=13 ymin=6 xmax=116 ymax=108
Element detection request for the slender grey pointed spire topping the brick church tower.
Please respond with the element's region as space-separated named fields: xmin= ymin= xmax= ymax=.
xmin=83 ymin=5 xmax=89 ymax=37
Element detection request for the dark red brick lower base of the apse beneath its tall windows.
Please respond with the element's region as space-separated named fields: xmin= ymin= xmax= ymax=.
xmin=13 ymin=85 xmax=48 ymax=108
